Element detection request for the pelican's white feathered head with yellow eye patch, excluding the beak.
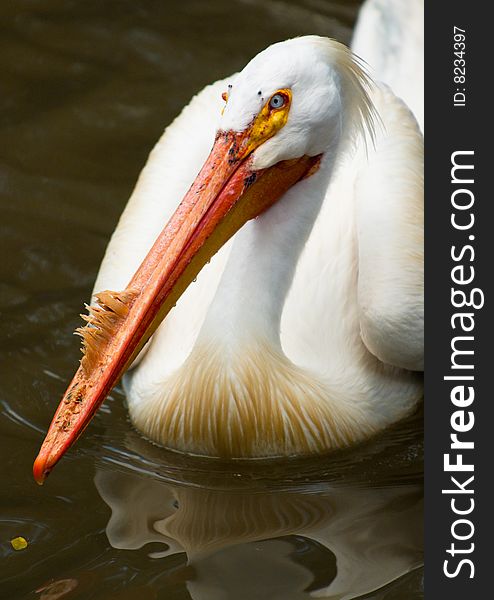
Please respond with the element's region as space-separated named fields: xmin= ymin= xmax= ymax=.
xmin=220 ymin=36 xmax=374 ymax=169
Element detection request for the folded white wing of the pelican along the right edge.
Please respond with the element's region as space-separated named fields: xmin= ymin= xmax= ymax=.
xmin=355 ymin=86 xmax=424 ymax=370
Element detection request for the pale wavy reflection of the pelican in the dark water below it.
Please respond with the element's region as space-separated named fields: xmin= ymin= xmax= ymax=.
xmin=95 ymin=428 xmax=422 ymax=600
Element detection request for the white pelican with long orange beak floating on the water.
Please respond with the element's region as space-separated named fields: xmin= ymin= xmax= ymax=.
xmin=34 ymin=31 xmax=423 ymax=482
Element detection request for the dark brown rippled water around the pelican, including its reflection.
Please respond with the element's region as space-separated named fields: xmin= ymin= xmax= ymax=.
xmin=0 ymin=0 xmax=422 ymax=600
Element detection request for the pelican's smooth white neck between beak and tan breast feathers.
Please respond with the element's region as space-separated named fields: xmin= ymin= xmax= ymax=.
xmin=199 ymin=153 xmax=333 ymax=350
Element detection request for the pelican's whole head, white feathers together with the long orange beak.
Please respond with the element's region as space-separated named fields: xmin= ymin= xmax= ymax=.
xmin=34 ymin=36 xmax=372 ymax=482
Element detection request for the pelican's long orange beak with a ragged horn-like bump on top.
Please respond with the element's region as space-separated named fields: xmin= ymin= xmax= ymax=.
xmin=33 ymin=125 xmax=319 ymax=484
